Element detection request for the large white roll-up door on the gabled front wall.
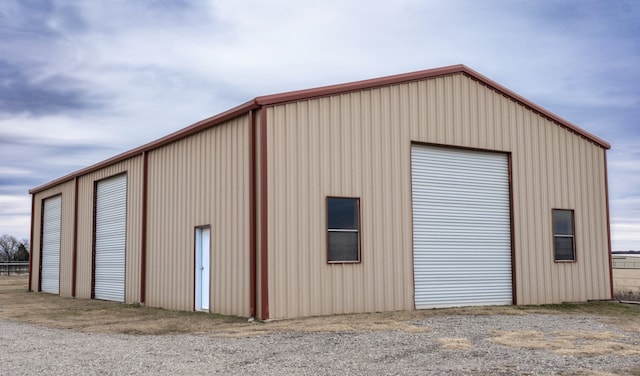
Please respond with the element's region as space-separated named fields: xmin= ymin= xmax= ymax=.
xmin=411 ymin=145 xmax=513 ymax=309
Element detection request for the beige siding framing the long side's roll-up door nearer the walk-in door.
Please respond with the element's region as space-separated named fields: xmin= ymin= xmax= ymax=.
xmin=76 ymin=156 xmax=143 ymax=303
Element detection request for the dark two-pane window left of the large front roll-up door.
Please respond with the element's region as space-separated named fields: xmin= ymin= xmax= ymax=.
xmin=327 ymin=197 xmax=360 ymax=262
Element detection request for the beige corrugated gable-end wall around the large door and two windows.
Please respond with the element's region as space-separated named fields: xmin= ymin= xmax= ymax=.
xmin=267 ymin=74 xmax=610 ymax=318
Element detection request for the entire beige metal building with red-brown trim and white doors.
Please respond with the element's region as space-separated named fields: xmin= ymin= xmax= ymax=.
xmin=29 ymin=65 xmax=612 ymax=319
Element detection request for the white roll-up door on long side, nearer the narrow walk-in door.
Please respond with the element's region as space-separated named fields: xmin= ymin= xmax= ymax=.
xmin=94 ymin=174 xmax=127 ymax=302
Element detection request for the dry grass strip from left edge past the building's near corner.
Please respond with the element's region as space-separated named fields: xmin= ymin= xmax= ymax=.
xmin=0 ymin=276 xmax=429 ymax=337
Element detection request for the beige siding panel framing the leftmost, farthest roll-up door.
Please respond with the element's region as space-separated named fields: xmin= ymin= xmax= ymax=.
xmin=30 ymin=180 xmax=75 ymax=297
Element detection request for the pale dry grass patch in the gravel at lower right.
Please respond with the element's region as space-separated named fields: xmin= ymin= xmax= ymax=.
xmin=491 ymin=330 xmax=640 ymax=356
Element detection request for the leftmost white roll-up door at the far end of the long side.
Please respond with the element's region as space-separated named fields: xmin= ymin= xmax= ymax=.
xmin=40 ymin=195 xmax=62 ymax=294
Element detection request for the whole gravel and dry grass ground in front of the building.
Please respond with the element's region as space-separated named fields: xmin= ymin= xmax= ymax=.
xmin=5 ymin=276 xmax=640 ymax=376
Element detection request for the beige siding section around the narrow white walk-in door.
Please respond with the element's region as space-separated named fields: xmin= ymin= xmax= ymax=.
xmin=146 ymin=116 xmax=250 ymax=316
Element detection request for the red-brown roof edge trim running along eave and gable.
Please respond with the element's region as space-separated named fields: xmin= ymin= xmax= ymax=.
xmin=29 ymin=64 xmax=611 ymax=194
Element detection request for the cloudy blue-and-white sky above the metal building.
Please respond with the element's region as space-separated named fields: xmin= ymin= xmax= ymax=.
xmin=0 ymin=0 xmax=640 ymax=250
